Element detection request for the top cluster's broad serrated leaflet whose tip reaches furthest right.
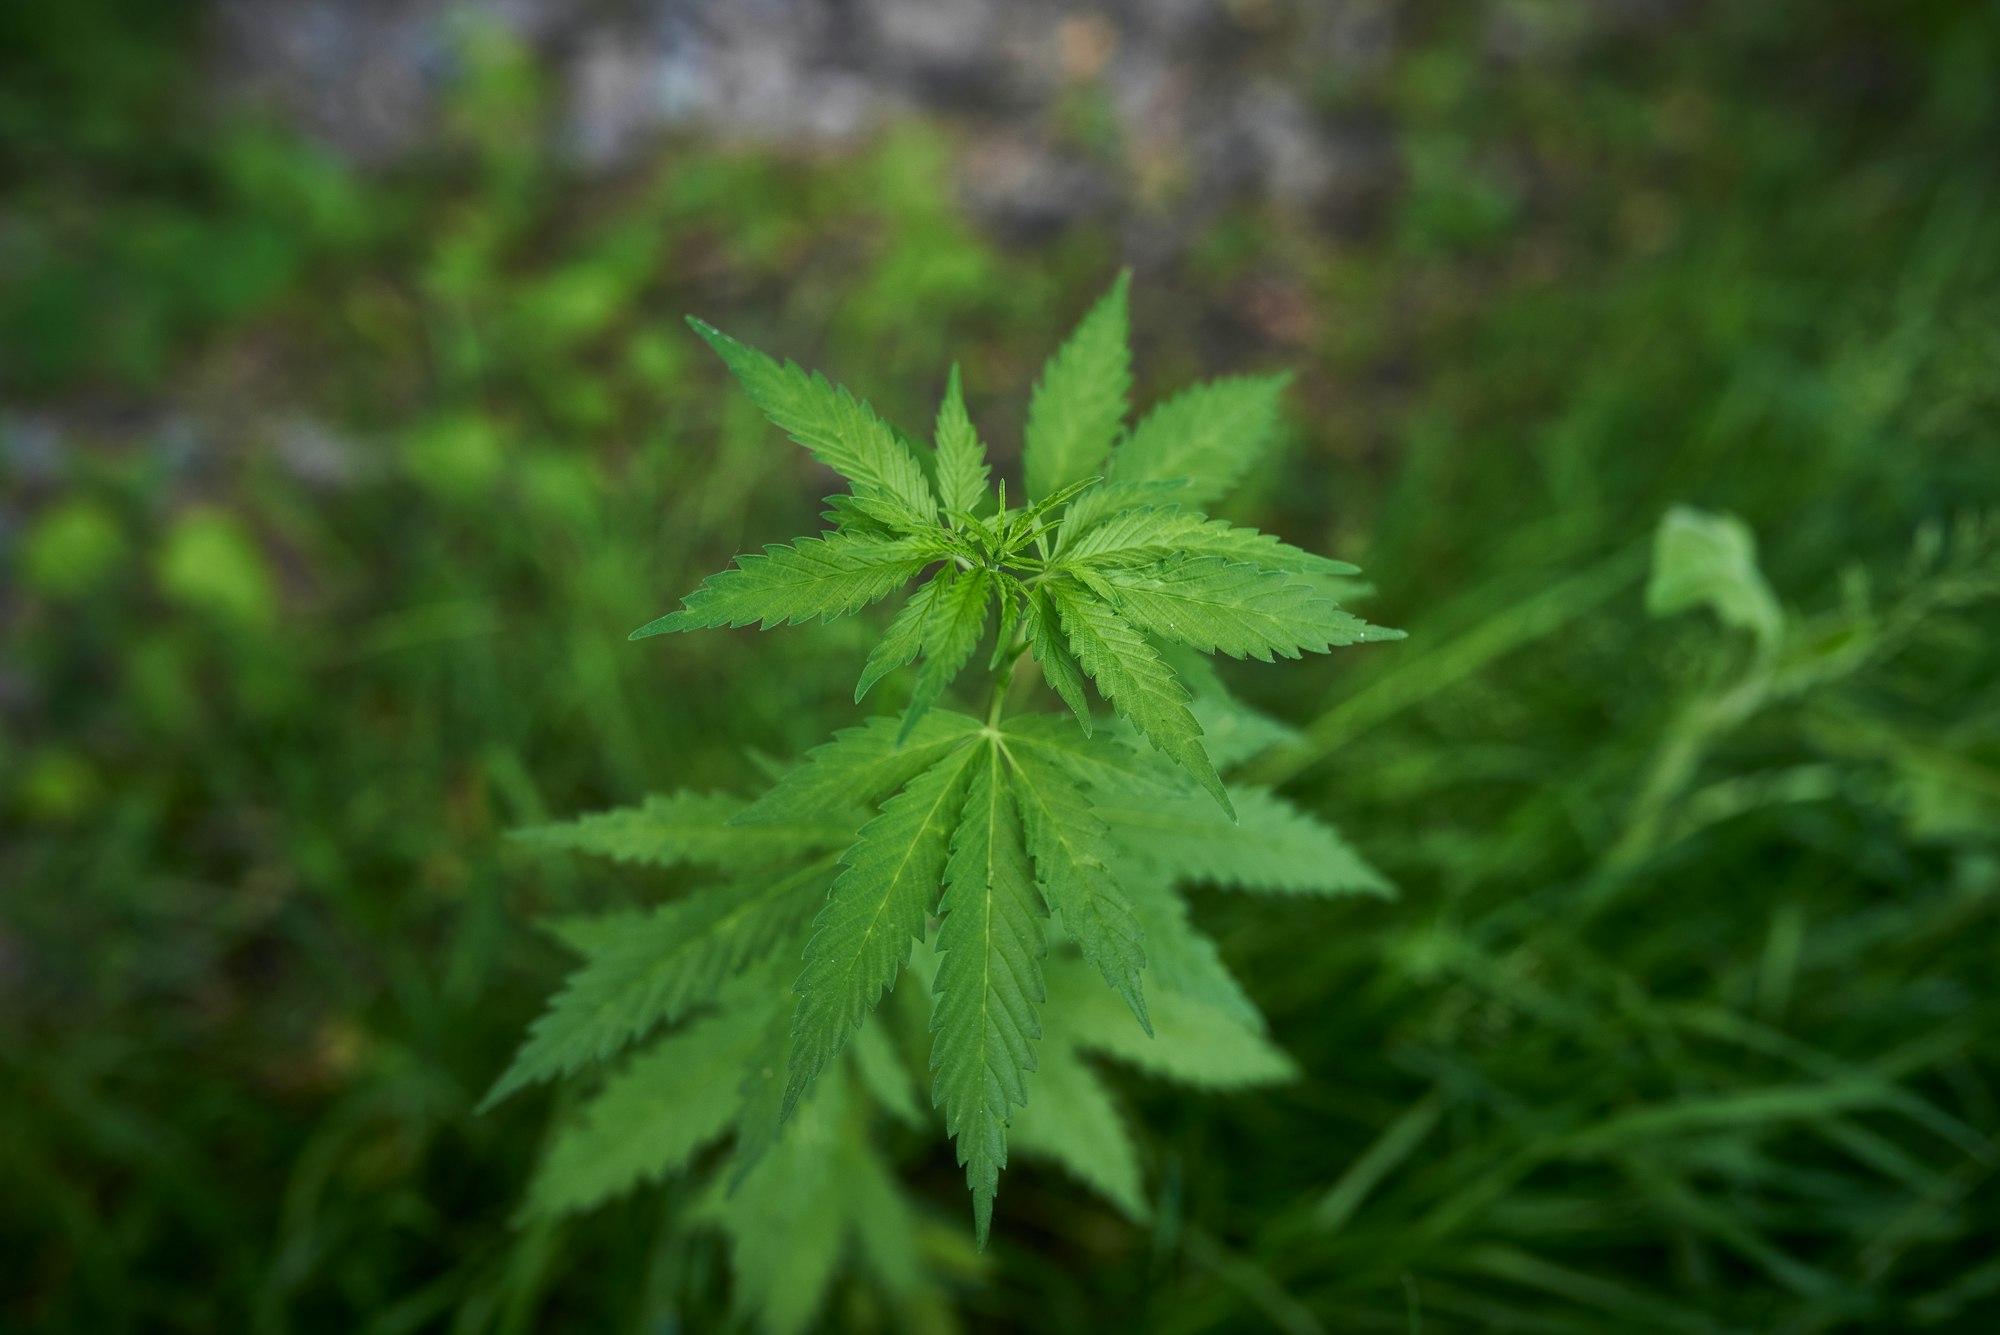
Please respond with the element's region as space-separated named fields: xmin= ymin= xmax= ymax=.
xmin=1096 ymin=556 xmax=1400 ymax=664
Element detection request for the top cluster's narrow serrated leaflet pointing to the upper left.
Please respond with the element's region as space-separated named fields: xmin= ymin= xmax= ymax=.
xmin=688 ymin=316 xmax=938 ymax=522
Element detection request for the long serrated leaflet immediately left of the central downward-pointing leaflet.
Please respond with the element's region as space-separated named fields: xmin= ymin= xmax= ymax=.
xmin=780 ymin=745 xmax=986 ymax=1117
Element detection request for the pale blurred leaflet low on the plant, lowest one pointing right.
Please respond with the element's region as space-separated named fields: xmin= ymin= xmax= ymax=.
xmin=1048 ymin=961 xmax=1298 ymax=1089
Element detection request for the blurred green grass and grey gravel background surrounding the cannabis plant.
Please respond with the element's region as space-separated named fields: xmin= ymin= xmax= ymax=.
xmin=0 ymin=0 xmax=2000 ymax=1335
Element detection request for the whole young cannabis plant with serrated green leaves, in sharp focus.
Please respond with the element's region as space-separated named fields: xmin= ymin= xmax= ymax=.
xmin=488 ymin=278 xmax=1400 ymax=1271
